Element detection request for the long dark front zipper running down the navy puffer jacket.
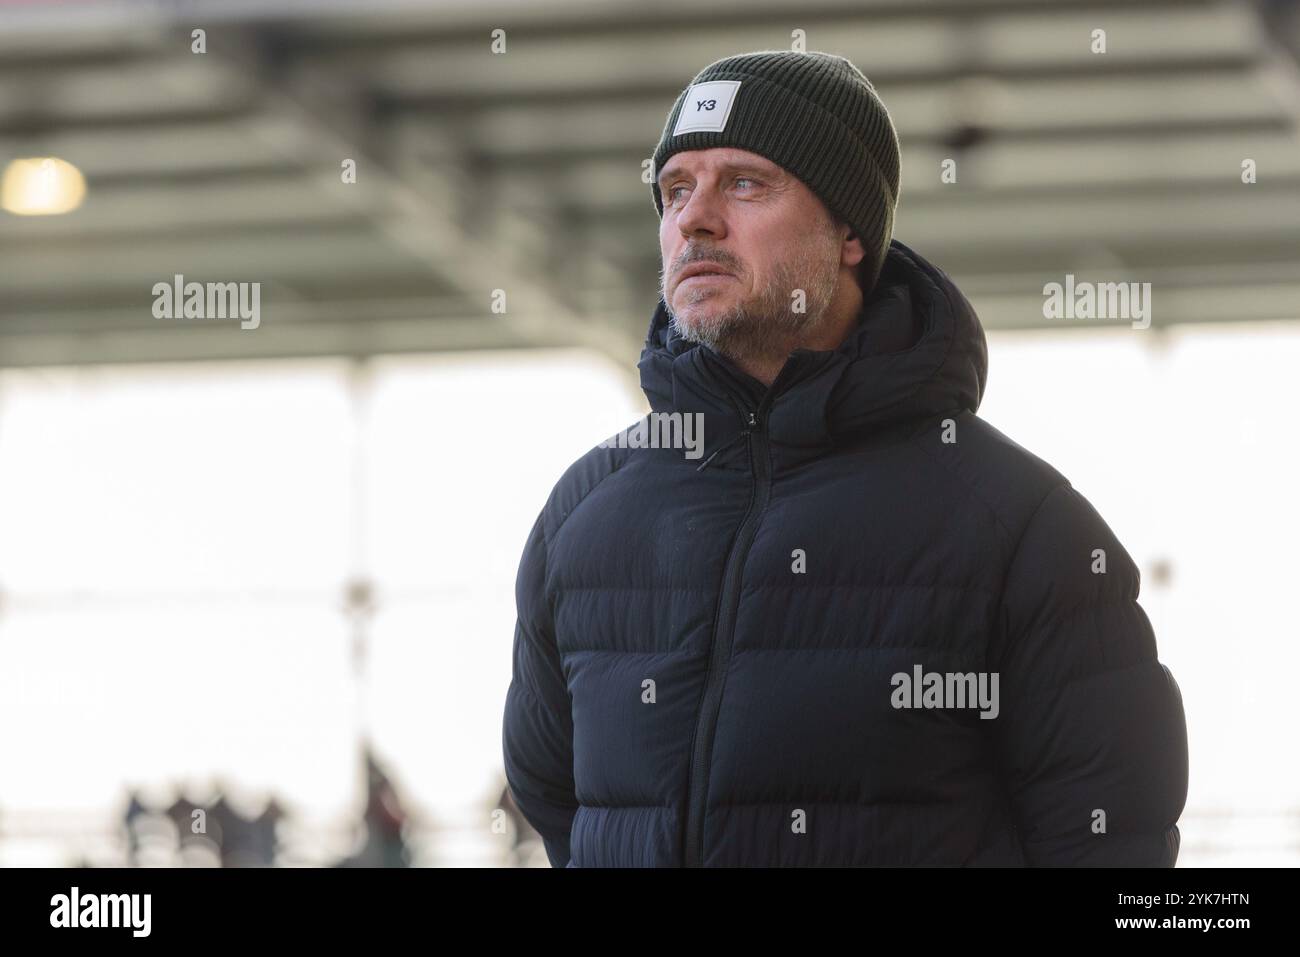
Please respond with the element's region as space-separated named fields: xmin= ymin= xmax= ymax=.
xmin=683 ymin=399 xmax=772 ymax=867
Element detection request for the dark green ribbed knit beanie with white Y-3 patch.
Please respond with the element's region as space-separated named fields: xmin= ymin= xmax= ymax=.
xmin=650 ymin=49 xmax=898 ymax=295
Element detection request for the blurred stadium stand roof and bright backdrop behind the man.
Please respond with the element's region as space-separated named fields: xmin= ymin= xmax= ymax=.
xmin=0 ymin=0 xmax=1300 ymax=866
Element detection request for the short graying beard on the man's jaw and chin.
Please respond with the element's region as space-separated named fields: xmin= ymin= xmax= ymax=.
xmin=664 ymin=234 xmax=839 ymax=363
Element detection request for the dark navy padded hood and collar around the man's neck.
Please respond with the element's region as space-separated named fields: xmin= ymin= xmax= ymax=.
xmin=637 ymin=239 xmax=988 ymax=468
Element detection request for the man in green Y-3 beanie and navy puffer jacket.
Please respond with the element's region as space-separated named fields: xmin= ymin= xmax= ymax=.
xmin=503 ymin=52 xmax=1187 ymax=867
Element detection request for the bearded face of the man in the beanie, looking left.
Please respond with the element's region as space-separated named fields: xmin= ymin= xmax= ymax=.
xmin=659 ymin=147 xmax=842 ymax=358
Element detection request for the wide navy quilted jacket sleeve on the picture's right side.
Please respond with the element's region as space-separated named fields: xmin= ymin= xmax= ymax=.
xmin=989 ymin=484 xmax=1187 ymax=867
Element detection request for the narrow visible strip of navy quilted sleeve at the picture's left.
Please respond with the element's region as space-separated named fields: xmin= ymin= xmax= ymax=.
xmin=502 ymin=515 xmax=577 ymax=867
